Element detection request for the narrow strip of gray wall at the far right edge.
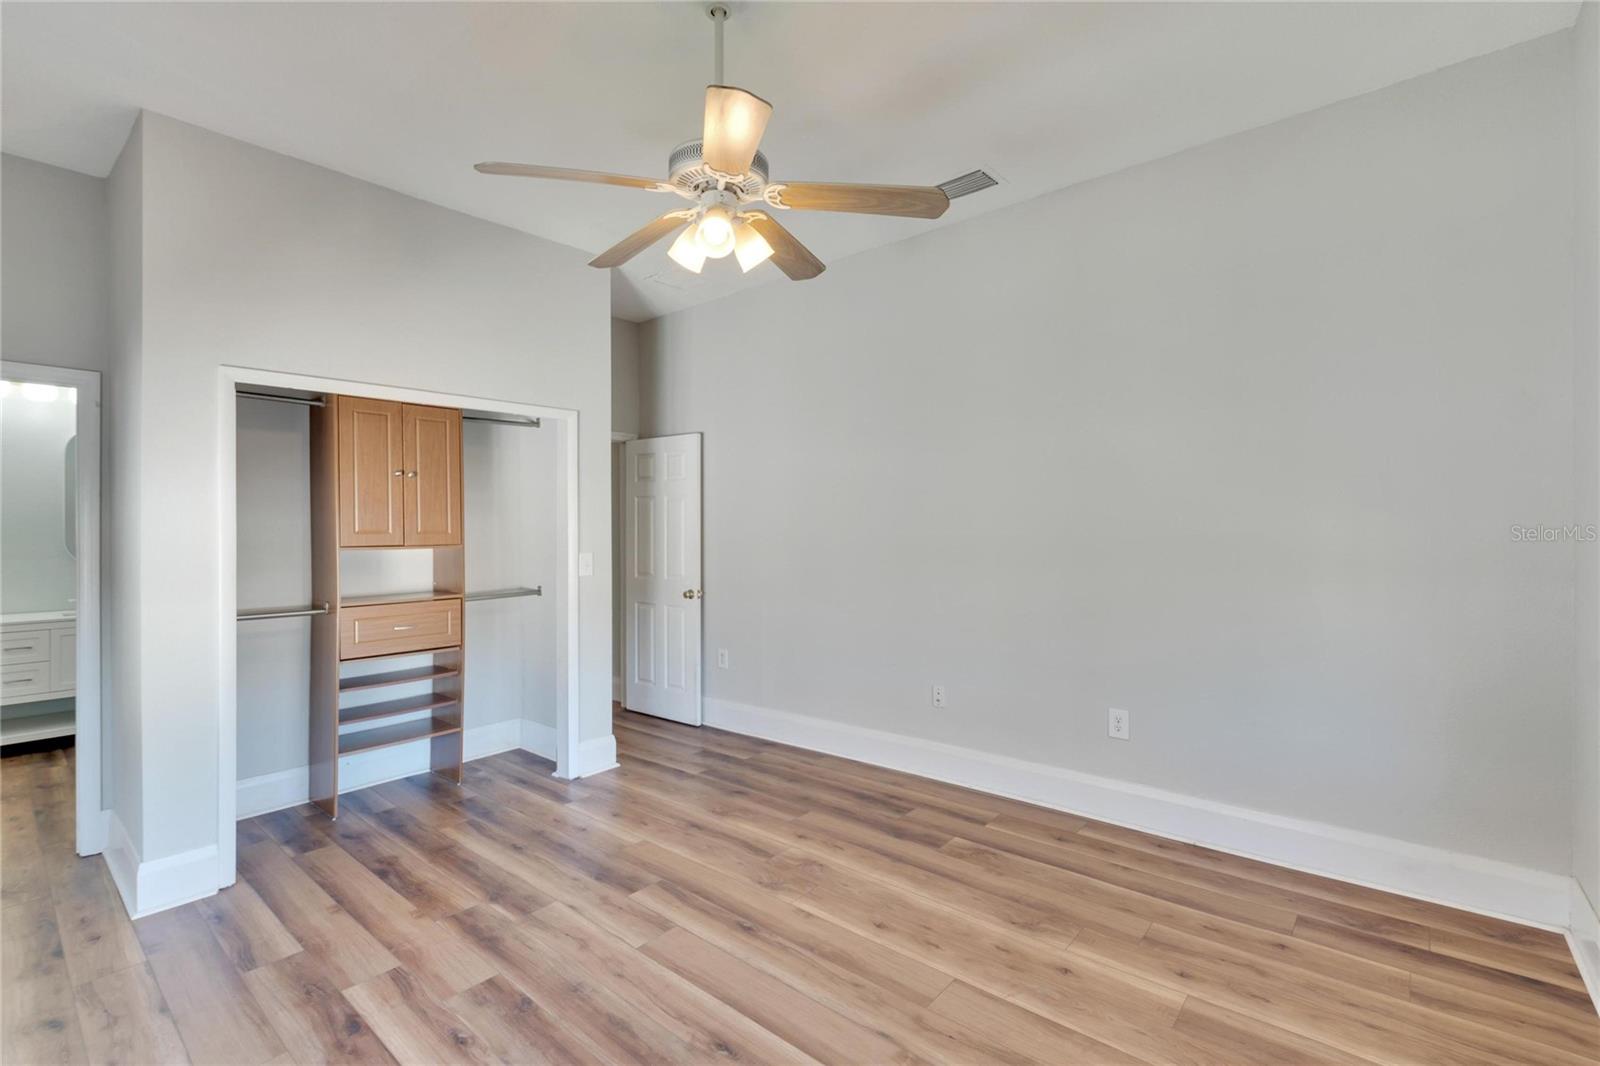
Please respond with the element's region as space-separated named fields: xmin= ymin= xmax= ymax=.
xmin=1573 ymin=0 xmax=1600 ymax=911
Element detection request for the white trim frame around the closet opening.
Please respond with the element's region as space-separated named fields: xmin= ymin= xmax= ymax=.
xmin=216 ymin=365 xmax=582 ymax=888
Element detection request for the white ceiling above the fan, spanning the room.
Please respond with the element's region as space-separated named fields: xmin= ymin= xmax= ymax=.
xmin=0 ymin=2 xmax=1578 ymax=320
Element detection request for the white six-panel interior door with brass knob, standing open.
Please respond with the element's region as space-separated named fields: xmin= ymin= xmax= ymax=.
xmin=622 ymin=434 xmax=701 ymax=725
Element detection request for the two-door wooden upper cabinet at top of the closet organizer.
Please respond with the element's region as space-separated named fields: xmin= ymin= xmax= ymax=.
xmin=334 ymin=395 xmax=461 ymax=547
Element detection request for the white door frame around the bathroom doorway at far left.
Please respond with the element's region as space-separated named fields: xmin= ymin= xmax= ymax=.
xmin=0 ymin=360 xmax=110 ymax=855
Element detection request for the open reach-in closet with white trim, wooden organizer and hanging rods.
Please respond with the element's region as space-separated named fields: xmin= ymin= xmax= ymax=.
xmin=219 ymin=370 xmax=579 ymax=885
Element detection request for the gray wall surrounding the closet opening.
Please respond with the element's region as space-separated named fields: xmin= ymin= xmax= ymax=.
xmin=114 ymin=112 xmax=611 ymax=861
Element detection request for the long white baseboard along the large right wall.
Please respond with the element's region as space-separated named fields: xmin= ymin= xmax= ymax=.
xmin=704 ymin=699 xmax=1571 ymax=930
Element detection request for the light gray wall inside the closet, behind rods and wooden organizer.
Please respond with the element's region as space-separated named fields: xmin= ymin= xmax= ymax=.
xmin=238 ymin=393 xmax=560 ymax=784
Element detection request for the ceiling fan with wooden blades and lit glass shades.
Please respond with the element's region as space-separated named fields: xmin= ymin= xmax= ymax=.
xmin=477 ymin=3 xmax=950 ymax=282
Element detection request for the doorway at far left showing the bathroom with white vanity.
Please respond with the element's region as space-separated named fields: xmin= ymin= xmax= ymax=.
xmin=0 ymin=362 xmax=107 ymax=855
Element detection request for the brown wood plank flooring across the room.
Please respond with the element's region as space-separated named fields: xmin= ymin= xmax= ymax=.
xmin=0 ymin=712 xmax=1600 ymax=1066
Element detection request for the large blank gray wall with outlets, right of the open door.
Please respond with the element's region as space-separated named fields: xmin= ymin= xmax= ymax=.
xmin=642 ymin=35 xmax=1574 ymax=872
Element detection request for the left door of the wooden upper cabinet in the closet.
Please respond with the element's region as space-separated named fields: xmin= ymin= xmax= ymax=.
xmin=336 ymin=395 xmax=411 ymax=547
